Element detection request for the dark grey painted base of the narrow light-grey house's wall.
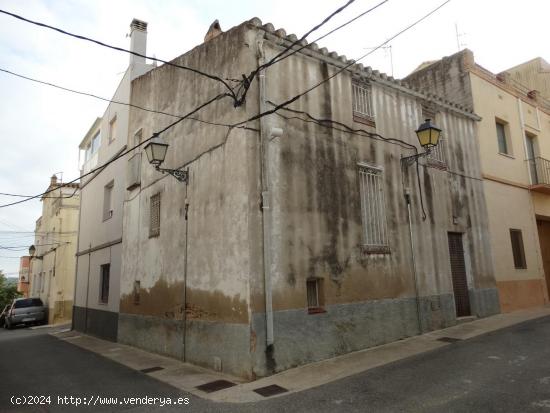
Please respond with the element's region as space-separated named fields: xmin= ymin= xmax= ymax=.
xmin=73 ymin=306 xmax=118 ymax=341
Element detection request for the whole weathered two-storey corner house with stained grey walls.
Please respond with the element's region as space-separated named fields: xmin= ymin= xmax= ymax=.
xmin=118 ymin=18 xmax=499 ymax=378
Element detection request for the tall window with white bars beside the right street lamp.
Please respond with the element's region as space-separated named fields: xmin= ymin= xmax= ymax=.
xmin=359 ymin=164 xmax=389 ymax=253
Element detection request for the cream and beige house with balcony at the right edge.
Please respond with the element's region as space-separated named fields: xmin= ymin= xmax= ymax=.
xmin=405 ymin=49 xmax=550 ymax=311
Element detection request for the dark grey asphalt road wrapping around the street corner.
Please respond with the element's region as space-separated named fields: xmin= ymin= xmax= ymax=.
xmin=0 ymin=317 xmax=550 ymax=413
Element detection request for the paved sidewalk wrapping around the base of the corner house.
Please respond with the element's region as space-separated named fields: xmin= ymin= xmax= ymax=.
xmin=51 ymin=307 xmax=550 ymax=403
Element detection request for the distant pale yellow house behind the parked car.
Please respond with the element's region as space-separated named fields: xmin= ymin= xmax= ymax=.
xmin=29 ymin=175 xmax=80 ymax=324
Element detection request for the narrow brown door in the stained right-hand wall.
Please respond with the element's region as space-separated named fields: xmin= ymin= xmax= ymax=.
xmin=449 ymin=232 xmax=471 ymax=317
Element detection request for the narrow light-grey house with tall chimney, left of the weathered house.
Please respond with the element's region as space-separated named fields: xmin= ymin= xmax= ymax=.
xmin=73 ymin=19 xmax=153 ymax=340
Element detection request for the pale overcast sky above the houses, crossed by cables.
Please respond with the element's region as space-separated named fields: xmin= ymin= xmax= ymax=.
xmin=0 ymin=0 xmax=550 ymax=276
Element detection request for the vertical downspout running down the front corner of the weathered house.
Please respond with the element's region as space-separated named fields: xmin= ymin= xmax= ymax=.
xmin=258 ymin=39 xmax=274 ymax=350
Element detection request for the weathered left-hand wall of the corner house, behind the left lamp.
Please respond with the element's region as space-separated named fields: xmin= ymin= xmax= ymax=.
xmin=118 ymin=21 xmax=261 ymax=377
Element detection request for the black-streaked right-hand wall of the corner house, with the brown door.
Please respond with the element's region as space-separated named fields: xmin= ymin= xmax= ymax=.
xmin=248 ymin=33 xmax=499 ymax=375
